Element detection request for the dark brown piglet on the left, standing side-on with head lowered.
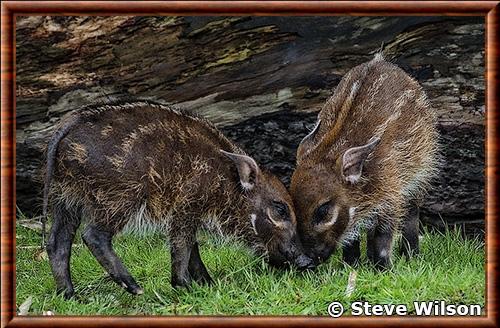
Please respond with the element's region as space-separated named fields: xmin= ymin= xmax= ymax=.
xmin=44 ymin=101 xmax=313 ymax=297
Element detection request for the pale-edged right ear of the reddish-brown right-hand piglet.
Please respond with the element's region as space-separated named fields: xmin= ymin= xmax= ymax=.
xmin=342 ymin=137 xmax=380 ymax=184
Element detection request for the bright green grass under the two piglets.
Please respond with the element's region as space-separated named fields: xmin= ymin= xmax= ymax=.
xmin=16 ymin=220 xmax=485 ymax=315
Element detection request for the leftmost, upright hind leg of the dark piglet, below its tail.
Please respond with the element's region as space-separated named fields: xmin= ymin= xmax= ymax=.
xmin=47 ymin=204 xmax=81 ymax=299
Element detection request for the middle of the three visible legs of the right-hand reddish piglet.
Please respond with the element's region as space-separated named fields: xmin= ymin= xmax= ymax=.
xmin=367 ymin=223 xmax=393 ymax=270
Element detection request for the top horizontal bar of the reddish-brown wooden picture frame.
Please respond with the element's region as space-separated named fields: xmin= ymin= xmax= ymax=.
xmin=1 ymin=0 xmax=498 ymax=16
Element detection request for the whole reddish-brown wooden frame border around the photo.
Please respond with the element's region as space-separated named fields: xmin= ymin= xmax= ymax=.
xmin=1 ymin=1 xmax=500 ymax=327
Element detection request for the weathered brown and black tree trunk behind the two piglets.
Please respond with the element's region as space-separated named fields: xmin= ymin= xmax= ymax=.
xmin=16 ymin=16 xmax=485 ymax=234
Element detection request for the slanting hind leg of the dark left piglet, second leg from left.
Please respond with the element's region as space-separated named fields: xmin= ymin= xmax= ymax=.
xmin=82 ymin=224 xmax=144 ymax=295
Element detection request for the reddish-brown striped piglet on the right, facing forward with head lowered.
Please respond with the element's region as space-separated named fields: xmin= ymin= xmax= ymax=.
xmin=290 ymin=54 xmax=439 ymax=268
